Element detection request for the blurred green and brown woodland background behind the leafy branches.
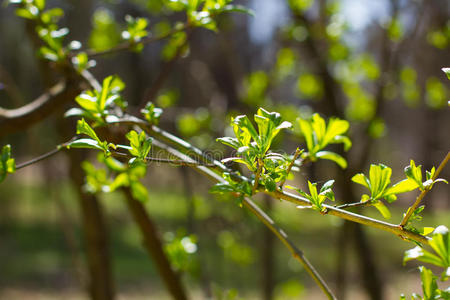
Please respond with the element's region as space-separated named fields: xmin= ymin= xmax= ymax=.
xmin=0 ymin=0 xmax=450 ymax=299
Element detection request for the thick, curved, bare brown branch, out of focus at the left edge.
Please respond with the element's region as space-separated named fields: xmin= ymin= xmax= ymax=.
xmin=0 ymin=81 xmax=81 ymax=137
